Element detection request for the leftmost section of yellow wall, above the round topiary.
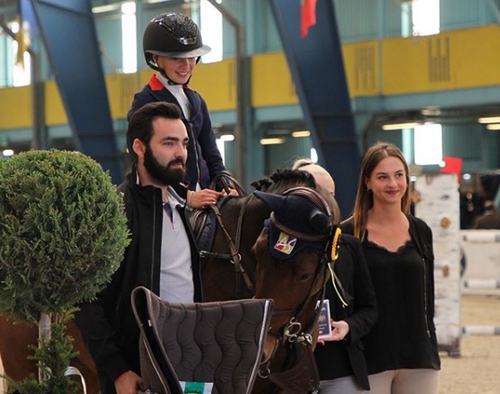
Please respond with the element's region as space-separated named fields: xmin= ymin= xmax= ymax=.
xmin=0 ymin=86 xmax=33 ymax=130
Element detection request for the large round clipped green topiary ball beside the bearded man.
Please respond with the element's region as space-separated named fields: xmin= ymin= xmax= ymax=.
xmin=0 ymin=150 xmax=129 ymax=322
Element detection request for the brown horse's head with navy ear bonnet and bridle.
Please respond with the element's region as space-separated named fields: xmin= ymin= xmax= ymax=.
xmin=253 ymin=187 xmax=338 ymax=386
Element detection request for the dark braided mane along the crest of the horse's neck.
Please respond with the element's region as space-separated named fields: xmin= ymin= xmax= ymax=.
xmin=251 ymin=169 xmax=317 ymax=194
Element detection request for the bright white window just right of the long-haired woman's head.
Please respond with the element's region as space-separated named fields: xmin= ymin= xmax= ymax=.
xmin=413 ymin=124 xmax=443 ymax=165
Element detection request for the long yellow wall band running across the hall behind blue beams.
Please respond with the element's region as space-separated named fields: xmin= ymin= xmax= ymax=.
xmin=0 ymin=24 xmax=500 ymax=130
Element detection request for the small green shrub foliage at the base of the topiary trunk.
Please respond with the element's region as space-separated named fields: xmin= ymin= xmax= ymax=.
xmin=7 ymin=311 xmax=81 ymax=394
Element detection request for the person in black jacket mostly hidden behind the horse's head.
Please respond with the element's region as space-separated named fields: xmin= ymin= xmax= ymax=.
xmin=293 ymin=159 xmax=377 ymax=394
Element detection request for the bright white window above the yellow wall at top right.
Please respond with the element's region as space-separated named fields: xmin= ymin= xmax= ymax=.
xmin=401 ymin=0 xmax=439 ymax=37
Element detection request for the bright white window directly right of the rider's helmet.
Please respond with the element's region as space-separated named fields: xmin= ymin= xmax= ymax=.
xmin=200 ymin=0 xmax=222 ymax=63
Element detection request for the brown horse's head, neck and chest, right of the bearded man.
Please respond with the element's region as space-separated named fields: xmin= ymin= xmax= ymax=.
xmin=197 ymin=170 xmax=339 ymax=394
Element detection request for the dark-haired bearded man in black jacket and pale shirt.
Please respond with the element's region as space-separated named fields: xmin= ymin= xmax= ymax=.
xmin=75 ymin=102 xmax=202 ymax=394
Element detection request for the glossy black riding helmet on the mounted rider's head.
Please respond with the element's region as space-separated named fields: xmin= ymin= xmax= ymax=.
xmin=142 ymin=12 xmax=210 ymax=71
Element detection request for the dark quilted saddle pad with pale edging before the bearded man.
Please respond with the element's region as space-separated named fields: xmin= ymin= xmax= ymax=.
xmin=132 ymin=287 xmax=273 ymax=394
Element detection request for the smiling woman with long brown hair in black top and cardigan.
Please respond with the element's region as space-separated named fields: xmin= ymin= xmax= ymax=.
xmin=342 ymin=142 xmax=440 ymax=394
